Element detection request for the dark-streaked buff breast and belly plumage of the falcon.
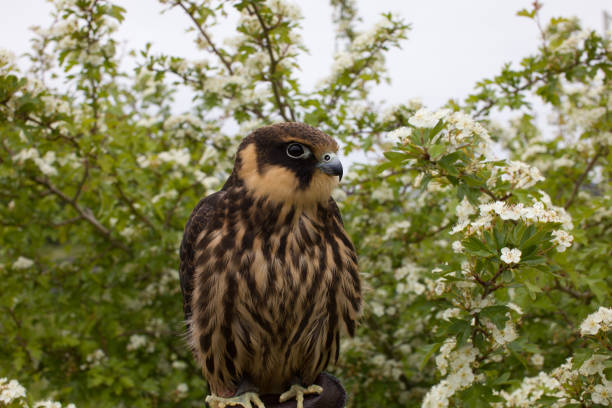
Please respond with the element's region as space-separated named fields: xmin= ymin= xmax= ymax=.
xmin=192 ymin=190 xmax=359 ymax=392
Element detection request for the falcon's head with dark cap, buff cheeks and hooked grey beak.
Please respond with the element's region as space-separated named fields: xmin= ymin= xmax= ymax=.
xmin=230 ymin=122 xmax=342 ymax=206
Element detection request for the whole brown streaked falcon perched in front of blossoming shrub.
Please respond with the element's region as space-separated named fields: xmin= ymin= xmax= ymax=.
xmin=180 ymin=123 xmax=361 ymax=408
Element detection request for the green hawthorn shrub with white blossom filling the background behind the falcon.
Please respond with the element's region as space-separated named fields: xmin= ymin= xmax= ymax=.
xmin=0 ymin=0 xmax=612 ymax=407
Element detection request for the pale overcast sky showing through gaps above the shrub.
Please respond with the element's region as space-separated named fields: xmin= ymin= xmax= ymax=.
xmin=0 ymin=0 xmax=612 ymax=118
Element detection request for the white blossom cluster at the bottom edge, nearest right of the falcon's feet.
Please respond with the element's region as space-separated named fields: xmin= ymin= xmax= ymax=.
xmin=421 ymin=339 xmax=481 ymax=408
